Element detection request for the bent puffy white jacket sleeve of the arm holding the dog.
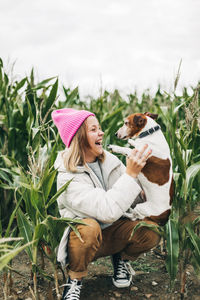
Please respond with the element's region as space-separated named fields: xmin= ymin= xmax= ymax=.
xmin=58 ymin=173 xmax=141 ymax=223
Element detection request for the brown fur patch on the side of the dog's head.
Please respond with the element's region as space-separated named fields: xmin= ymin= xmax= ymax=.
xmin=125 ymin=113 xmax=147 ymax=137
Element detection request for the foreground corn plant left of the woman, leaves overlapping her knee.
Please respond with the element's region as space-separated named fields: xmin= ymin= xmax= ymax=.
xmin=1 ymin=142 xmax=86 ymax=299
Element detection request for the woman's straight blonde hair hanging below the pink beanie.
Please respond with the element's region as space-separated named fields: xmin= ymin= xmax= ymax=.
xmin=63 ymin=119 xmax=105 ymax=173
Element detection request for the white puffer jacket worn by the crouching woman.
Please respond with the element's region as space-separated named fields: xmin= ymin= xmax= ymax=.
xmin=54 ymin=150 xmax=141 ymax=265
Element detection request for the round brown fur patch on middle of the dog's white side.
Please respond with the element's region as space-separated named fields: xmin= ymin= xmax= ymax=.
xmin=141 ymin=156 xmax=170 ymax=185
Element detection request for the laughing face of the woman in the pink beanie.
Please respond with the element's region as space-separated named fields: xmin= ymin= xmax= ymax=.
xmin=85 ymin=116 xmax=104 ymax=162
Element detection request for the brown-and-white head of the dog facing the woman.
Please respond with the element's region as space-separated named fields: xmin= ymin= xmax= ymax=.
xmin=115 ymin=112 xmax=158 ymax=140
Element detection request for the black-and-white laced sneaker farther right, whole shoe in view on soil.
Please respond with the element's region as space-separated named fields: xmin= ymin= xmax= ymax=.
xmin=111 ymin=253 xmax=135 ymax=288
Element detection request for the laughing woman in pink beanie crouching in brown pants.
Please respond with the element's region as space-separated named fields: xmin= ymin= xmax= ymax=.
xmin=52 ymin=108 xmax=160 ymax=300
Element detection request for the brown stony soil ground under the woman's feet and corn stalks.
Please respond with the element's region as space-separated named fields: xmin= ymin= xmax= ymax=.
xmin=0 ymin=250 xmax=200 ymax=300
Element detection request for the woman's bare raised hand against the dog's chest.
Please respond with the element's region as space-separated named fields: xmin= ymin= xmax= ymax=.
xmin=126 ymin=145 xmax=152 ymax=178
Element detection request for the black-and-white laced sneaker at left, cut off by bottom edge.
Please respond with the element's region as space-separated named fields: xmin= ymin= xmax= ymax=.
xmin=62 ymin=277 xmax=82 ymax=300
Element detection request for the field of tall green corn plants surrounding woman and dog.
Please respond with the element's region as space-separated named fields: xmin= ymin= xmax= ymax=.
xmin=0 ymin=56 xmax=200 ymax=299
